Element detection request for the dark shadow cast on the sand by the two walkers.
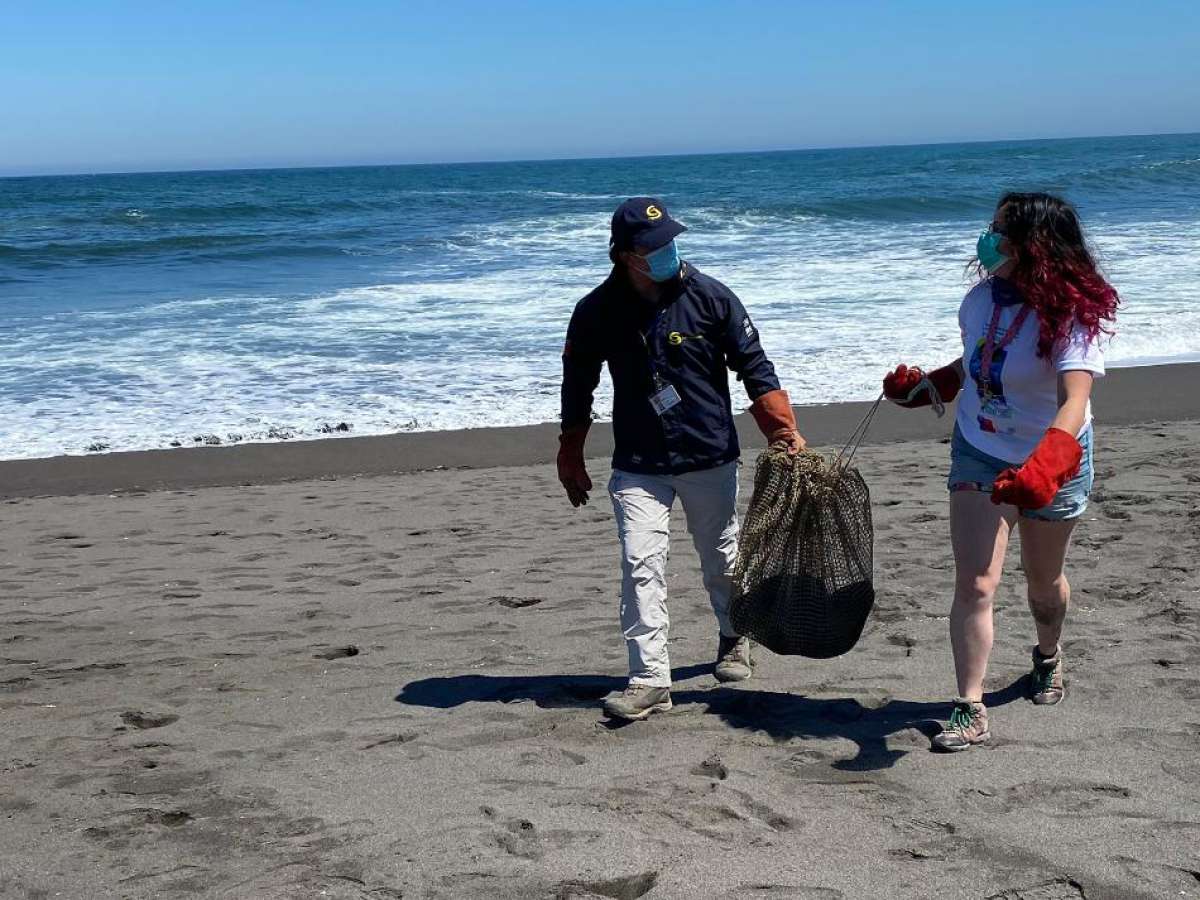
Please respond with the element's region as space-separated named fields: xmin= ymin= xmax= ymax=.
xmin=396 ymin=665 xmax=1026 ymax=772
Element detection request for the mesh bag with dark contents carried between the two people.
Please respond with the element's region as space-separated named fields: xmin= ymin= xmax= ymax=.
xmin=730 ymin=449 xmax=875 ymax=659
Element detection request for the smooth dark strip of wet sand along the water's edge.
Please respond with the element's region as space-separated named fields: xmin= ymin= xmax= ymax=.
xmin=0 ymin=364 xmax=1200 ymax=498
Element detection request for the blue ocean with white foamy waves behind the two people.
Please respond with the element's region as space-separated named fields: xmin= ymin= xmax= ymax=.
xmin=0 ymin=134 xmax=1200 ymax=458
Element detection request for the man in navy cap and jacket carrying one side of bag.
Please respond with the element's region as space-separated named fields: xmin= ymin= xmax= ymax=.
xmin=558 ymin=197 xmax=804 ymax=719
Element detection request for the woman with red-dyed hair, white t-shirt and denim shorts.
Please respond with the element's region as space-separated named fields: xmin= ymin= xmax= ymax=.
xmin=883 ymin=193 xmax=1120 ymax=751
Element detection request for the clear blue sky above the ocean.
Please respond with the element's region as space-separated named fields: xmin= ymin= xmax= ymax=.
xmin=0 ymin=0 xmax=1200 ymax=174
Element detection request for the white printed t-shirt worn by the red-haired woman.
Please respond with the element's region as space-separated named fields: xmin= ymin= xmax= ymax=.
xmin=956 ymin=278 xmax=1104 ymax=464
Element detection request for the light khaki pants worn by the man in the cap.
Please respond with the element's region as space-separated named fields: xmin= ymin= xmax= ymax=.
xmin=608 ymin=461 xmax=738 ymax=688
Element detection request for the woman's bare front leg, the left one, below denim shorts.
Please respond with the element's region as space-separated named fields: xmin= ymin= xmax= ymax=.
xmin=950 ymin=491 xmax=1016 ymax=702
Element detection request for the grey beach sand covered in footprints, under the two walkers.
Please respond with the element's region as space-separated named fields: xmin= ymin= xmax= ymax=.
xmin=0 ymin=367 xmax=1200 ymax=900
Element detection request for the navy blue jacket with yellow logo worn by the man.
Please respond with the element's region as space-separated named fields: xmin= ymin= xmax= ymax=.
xmin=563 ymin=263 xmax=779 ymax=475
